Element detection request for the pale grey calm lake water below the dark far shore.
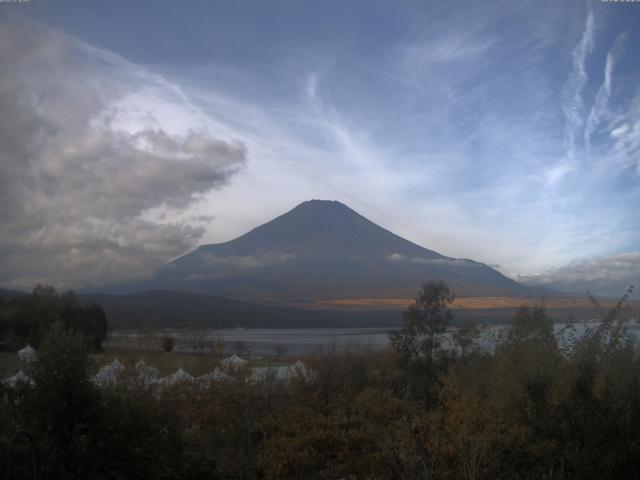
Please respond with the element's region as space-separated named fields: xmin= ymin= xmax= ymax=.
xmin=106 ymin=322 xmax=640 ymax=355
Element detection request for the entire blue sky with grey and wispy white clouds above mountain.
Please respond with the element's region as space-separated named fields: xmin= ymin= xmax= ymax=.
xmin=0 ymin=0 xmax=640 ymax=295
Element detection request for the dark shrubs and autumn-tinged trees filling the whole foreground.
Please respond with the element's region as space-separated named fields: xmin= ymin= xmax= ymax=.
xmin=0 ymin=283 xmax=640 ymax=479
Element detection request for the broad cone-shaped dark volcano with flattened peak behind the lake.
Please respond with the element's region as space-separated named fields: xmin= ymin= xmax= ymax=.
xmin=148 ymin=200 xmax=530 ymax=302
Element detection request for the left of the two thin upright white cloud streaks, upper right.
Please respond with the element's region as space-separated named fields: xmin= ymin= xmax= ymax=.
xmin=562 ymin=10 xmax=594 ymax=160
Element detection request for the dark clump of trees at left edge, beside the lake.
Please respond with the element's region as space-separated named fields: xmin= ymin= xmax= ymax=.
xmin=0 ymin=285 xmax=108 ymax=350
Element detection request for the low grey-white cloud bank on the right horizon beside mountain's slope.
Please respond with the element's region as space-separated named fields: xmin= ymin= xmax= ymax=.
xmin=515 ymin=252 xmax=640 ymax=297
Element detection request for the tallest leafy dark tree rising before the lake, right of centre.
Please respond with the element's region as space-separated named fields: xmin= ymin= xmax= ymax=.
xmin=389 ymin=280 xmax=455 ymax=401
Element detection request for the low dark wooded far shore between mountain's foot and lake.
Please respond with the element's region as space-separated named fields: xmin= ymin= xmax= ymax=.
xmin=0 ymin=289 xmax=598 ymax=329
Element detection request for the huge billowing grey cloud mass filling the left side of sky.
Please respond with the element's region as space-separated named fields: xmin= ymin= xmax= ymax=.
xmin=0 ymin=19 xmax=247 ymax=287
